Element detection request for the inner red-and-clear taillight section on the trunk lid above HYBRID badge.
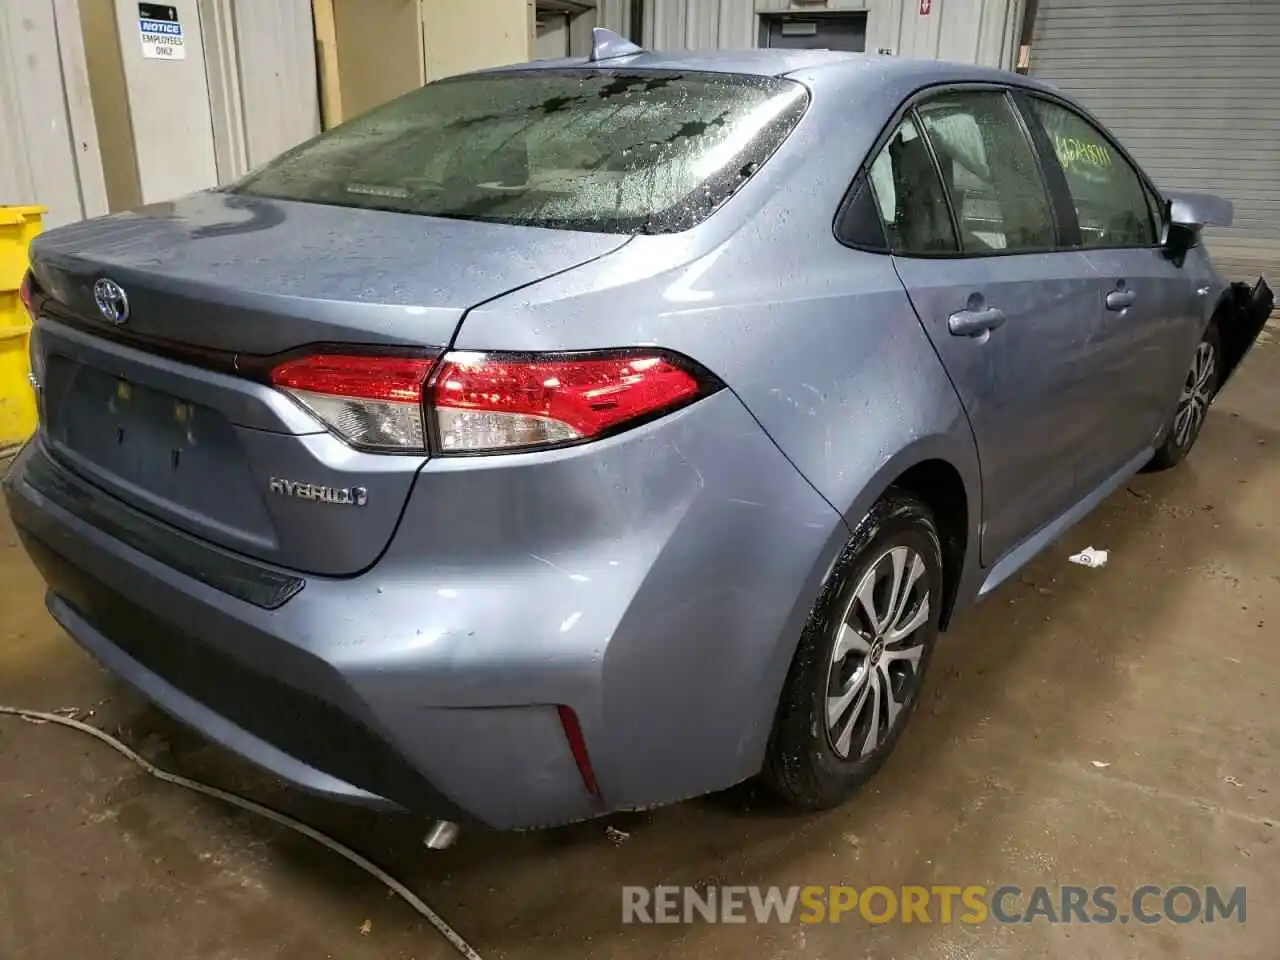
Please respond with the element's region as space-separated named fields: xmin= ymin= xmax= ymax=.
xmin=271 ymin=353 xmax=434 ymax=452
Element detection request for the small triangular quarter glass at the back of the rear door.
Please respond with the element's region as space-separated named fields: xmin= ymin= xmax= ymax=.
xmin=869 ymin=119 xmax=959 ymax=255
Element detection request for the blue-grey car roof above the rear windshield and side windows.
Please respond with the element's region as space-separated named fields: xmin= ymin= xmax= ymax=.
xmin=486 ymin=49 xmax=1059 ymax=99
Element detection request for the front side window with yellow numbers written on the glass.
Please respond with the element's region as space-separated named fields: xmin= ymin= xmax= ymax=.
xmin=1032 ymin=97 xmax=1156 ymax=247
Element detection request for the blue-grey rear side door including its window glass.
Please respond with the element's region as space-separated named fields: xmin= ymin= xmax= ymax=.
xmin=872 ymin=86 xmax=1105 ymax=564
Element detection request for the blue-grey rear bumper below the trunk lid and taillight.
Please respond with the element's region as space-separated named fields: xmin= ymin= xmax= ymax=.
xmin=5 ymin=392 xmax=846 ymax=828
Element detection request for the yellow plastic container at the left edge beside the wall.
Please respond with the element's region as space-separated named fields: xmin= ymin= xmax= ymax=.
xmin=0 ymin=206 xmax=45 ymax=451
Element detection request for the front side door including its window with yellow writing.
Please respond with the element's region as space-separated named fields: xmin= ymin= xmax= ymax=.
xmin=1020 ymin=96 xmax=1206 ymax=492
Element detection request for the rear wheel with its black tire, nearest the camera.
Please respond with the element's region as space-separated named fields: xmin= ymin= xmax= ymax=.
xmin=763 ymin=490 xmax=943 ymax=810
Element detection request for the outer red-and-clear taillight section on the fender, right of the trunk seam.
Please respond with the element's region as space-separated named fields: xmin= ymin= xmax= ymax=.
xmin=429 ymin=351 xmax=703 ymax=453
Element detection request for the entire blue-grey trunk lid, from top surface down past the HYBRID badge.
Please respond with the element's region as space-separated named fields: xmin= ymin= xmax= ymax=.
xmin=32 ymin=192 xmax=627 ymax=576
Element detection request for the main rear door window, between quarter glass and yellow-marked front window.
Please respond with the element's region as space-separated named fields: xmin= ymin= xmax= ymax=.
xmin=918 ymin=91 xmax=1055 ymax=253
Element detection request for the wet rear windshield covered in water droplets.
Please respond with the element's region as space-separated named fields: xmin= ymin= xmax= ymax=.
xmin=232 ymin=69 xmax=808 ymax=233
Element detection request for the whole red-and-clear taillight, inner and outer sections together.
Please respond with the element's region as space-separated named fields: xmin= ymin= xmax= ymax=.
xmin=271 ymin=349 xmax=713 ymax=454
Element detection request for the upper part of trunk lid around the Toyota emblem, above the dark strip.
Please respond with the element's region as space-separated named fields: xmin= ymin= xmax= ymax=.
xmin=33 ymin=192 xmax=627 ymax=355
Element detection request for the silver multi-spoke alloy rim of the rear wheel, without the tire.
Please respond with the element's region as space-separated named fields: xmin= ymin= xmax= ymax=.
xmin=827 ymin=547 xmax=929 ymax=759
